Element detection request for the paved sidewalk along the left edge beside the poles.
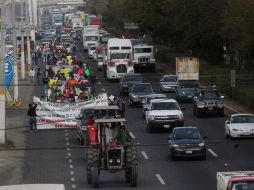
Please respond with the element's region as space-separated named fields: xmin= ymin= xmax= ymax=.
xmin=0 ymin=58 xmax=43 ymax=186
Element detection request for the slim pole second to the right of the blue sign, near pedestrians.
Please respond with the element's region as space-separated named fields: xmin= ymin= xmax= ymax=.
xmin=20 ymin=0 xmax=26 ymax=80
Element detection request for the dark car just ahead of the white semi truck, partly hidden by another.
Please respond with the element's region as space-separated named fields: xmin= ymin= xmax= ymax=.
xmin=120 ymin=74 xmax=142 ymax=96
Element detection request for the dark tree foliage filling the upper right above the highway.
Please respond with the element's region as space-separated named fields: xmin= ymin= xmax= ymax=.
xmin=89 ymin=0 xmax=254 ymax=67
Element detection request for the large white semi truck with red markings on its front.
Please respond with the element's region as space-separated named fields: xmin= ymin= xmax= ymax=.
xmin=107 ymin=38 xmax=134 ymax=79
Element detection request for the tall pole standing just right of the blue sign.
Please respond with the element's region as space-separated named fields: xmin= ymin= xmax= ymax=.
xmin=11 ymin=0 xmax=19 ymax=100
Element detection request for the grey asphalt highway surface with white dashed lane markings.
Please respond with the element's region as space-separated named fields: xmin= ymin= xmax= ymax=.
xmin=20 ymin=42 xmax=254 ymax=190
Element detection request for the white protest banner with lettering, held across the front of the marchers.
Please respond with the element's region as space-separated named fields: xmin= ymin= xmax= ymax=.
xmin=33 ymin=93 xmax=108 ymax=129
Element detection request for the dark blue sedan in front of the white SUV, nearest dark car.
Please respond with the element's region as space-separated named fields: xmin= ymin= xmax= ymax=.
xmin=169 ymin=127 xmax=206 ymax=160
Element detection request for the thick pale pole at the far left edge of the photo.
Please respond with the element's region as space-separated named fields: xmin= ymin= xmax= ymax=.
xmin=0 ymin=1 xmax=6 ymax=144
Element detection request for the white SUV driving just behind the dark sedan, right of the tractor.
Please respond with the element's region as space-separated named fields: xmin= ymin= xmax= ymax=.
xmin=145 ymin=99 xmax=184 ymax=133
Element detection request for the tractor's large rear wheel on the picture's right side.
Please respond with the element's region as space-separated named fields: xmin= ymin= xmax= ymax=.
xmin=125 ymin=146 xmax=138 ymax=187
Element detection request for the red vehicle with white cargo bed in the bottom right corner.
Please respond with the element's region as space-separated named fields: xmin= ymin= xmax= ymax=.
xmin=217 ymin=171 xmax=254 ymax=190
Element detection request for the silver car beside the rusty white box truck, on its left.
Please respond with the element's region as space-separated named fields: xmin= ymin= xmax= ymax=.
xmin=160 ymin=75 xmax=178 ymax=92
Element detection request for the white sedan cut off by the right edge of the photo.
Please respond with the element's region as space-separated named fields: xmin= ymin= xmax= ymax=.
xmin=225 ymin=114 xmax=254 ymax=139
